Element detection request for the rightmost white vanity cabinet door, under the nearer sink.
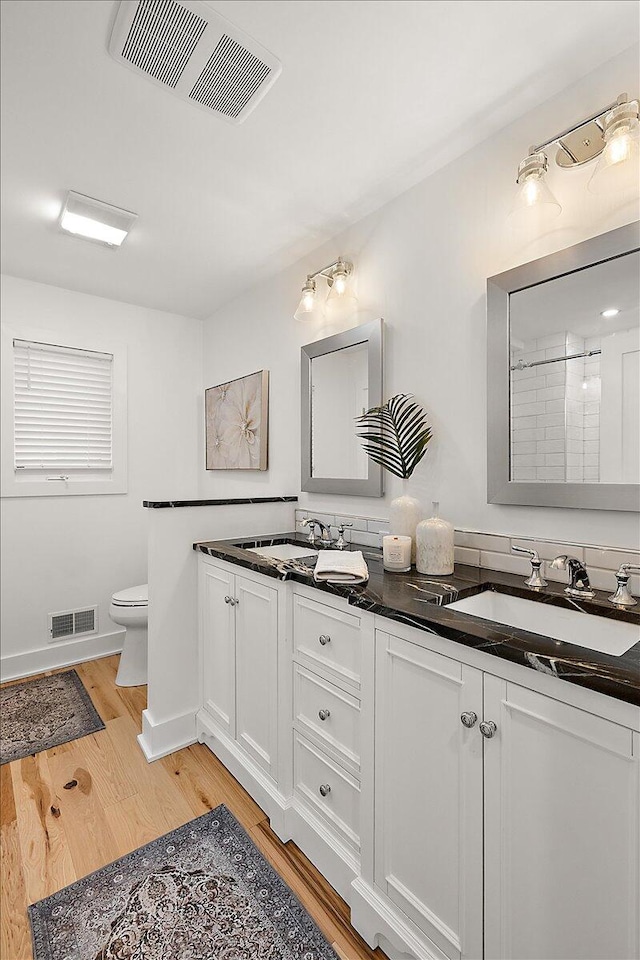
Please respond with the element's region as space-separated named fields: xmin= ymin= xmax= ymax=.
xmin=484 ymin=675 xmax=640 ymax=960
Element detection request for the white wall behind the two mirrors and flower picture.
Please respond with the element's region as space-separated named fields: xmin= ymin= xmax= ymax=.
xmin=201 ymin=46 xmax=639 ymax=547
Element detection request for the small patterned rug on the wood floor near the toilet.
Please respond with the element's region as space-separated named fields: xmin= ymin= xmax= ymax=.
xmin=0 ymin=670 xmax=104 ymax=763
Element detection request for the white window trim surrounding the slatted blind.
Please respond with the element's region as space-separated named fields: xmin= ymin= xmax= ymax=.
xmin=0 ymin=324 xmax=127 ymax=497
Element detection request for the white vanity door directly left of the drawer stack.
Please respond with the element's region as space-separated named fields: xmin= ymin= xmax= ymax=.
xmin=235 ymin=577 xmax=278 ymax=779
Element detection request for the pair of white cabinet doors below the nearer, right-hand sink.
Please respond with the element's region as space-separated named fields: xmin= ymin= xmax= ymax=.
xmin=374 ymin=632 xmax=640 ymax=960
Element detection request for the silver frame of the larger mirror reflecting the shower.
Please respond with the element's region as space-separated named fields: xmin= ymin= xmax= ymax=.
xmin=487 ymin=222 xmax=640 ymax=512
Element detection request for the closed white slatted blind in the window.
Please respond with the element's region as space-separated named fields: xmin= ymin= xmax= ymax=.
xmin=13 ymin=340 xmax=113 ymax=475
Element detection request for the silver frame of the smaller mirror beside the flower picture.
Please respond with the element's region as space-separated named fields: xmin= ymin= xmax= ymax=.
xmin=300 ymin=319 xmax=384 ymax=497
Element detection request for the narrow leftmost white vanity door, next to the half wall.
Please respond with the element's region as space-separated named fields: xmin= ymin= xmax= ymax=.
xmin=200 ymin=563 xmax=236 ymax=737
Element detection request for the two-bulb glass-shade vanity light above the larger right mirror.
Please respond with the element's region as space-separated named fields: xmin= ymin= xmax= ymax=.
xmin=511 ymin=93 xmax=640 ymax=225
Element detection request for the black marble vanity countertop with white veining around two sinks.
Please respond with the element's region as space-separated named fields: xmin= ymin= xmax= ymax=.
xmin=193 ymin=533 xmax=640 ymax=706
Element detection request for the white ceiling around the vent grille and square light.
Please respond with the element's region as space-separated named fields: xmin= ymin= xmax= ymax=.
xmin=2 ymin=0 xmax=638 ymax=317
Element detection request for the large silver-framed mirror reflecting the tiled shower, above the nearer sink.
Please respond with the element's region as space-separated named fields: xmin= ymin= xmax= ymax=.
xmin=487 ymin=223 xmax=640 ymax=511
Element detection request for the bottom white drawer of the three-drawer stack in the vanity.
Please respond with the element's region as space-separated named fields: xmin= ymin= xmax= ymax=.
xmin=293 ymin=732 xmax=360 ymax=852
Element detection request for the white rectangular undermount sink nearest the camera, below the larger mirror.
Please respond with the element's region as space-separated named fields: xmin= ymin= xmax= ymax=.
xmin=447 ymin=590 xmax=640 ymax=657
